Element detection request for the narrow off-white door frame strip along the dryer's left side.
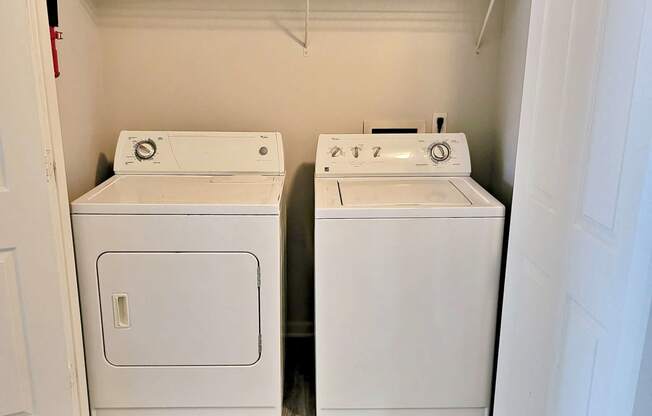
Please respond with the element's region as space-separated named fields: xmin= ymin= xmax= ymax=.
xmin=25 ymin=0 xmax=89 ymax=416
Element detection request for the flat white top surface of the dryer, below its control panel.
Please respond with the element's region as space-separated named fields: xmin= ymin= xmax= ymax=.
xmin=72 ymin=175 xmax=284 ymax=215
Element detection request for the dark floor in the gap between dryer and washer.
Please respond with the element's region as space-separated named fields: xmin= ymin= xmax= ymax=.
xmin=283 ymin=337 xmax=315 ymax=416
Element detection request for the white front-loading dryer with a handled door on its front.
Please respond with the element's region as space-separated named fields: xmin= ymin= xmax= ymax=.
xmin=72 ymin=131 xmax=285 ymax=416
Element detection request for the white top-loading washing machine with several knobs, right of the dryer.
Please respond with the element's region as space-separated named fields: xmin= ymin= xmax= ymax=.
xmin=315 ymin=134 xmax=505 ymax=416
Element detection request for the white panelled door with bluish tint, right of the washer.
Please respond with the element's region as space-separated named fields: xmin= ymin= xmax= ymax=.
xmin=494 ymin=0 xmax=652 ymax=416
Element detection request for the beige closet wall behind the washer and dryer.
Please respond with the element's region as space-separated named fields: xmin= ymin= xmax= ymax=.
xmin=59 ymin=0 xmax=513 ymax=332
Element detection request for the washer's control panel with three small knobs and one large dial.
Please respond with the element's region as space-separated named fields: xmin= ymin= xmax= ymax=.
xmin=315 ymin=133 xmax=471 ymax=177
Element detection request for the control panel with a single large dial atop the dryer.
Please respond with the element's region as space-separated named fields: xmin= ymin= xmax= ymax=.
xmin=113 ymin=131 xmax=285 ymax=175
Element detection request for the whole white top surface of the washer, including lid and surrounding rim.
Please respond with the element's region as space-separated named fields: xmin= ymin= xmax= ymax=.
xmin=315 ymin=177 xmax=505 ymax=219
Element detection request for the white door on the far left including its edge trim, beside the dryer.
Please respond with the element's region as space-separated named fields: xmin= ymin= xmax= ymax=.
xmin=0 ymin=0 xmax=86 ymax=416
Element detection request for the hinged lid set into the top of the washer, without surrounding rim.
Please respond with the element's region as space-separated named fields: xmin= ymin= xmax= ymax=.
xmin=338 ymin=178 xmax=471 ymax=207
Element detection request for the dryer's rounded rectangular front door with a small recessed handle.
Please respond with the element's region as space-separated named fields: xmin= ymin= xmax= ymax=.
xmin=97 ymin=252 xmax=260 ymax=366
